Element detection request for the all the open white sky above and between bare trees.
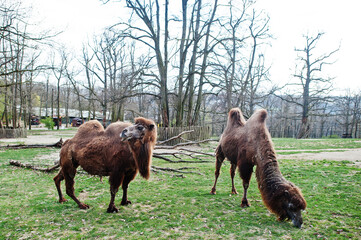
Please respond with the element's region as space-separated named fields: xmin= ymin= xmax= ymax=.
xmin=24 ymin=0 xmax=361 ymax=91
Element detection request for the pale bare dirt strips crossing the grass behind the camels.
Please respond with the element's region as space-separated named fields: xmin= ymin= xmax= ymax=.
xmin=0 ymin=130 xmax=361 ymax=168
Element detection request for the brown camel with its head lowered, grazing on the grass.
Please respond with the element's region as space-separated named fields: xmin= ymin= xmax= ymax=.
xmin=211 ymin=108 xmax=306 ymax=228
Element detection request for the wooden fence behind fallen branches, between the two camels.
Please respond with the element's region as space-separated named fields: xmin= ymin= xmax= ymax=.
xmin=158 ymin=126 xmax=211 ymax=145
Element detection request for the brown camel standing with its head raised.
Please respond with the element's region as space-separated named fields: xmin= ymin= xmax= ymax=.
xmin=54 ymin=118 xmax=157 ymax=213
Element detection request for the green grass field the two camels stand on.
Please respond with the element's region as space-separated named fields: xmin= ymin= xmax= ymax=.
xmin=0 ymin=139 xmax=361 ymax=239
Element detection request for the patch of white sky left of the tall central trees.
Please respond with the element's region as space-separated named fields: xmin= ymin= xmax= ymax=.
xmin=24 ymin=0 xmax=124 ymax=50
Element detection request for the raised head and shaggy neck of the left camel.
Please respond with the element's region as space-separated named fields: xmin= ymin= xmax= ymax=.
xmin=120 ymin=117 xmax=157 ymax=179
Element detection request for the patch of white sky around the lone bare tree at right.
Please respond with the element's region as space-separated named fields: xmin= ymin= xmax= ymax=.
xmin=257 ymin=0 xmax=361 ymax=94
